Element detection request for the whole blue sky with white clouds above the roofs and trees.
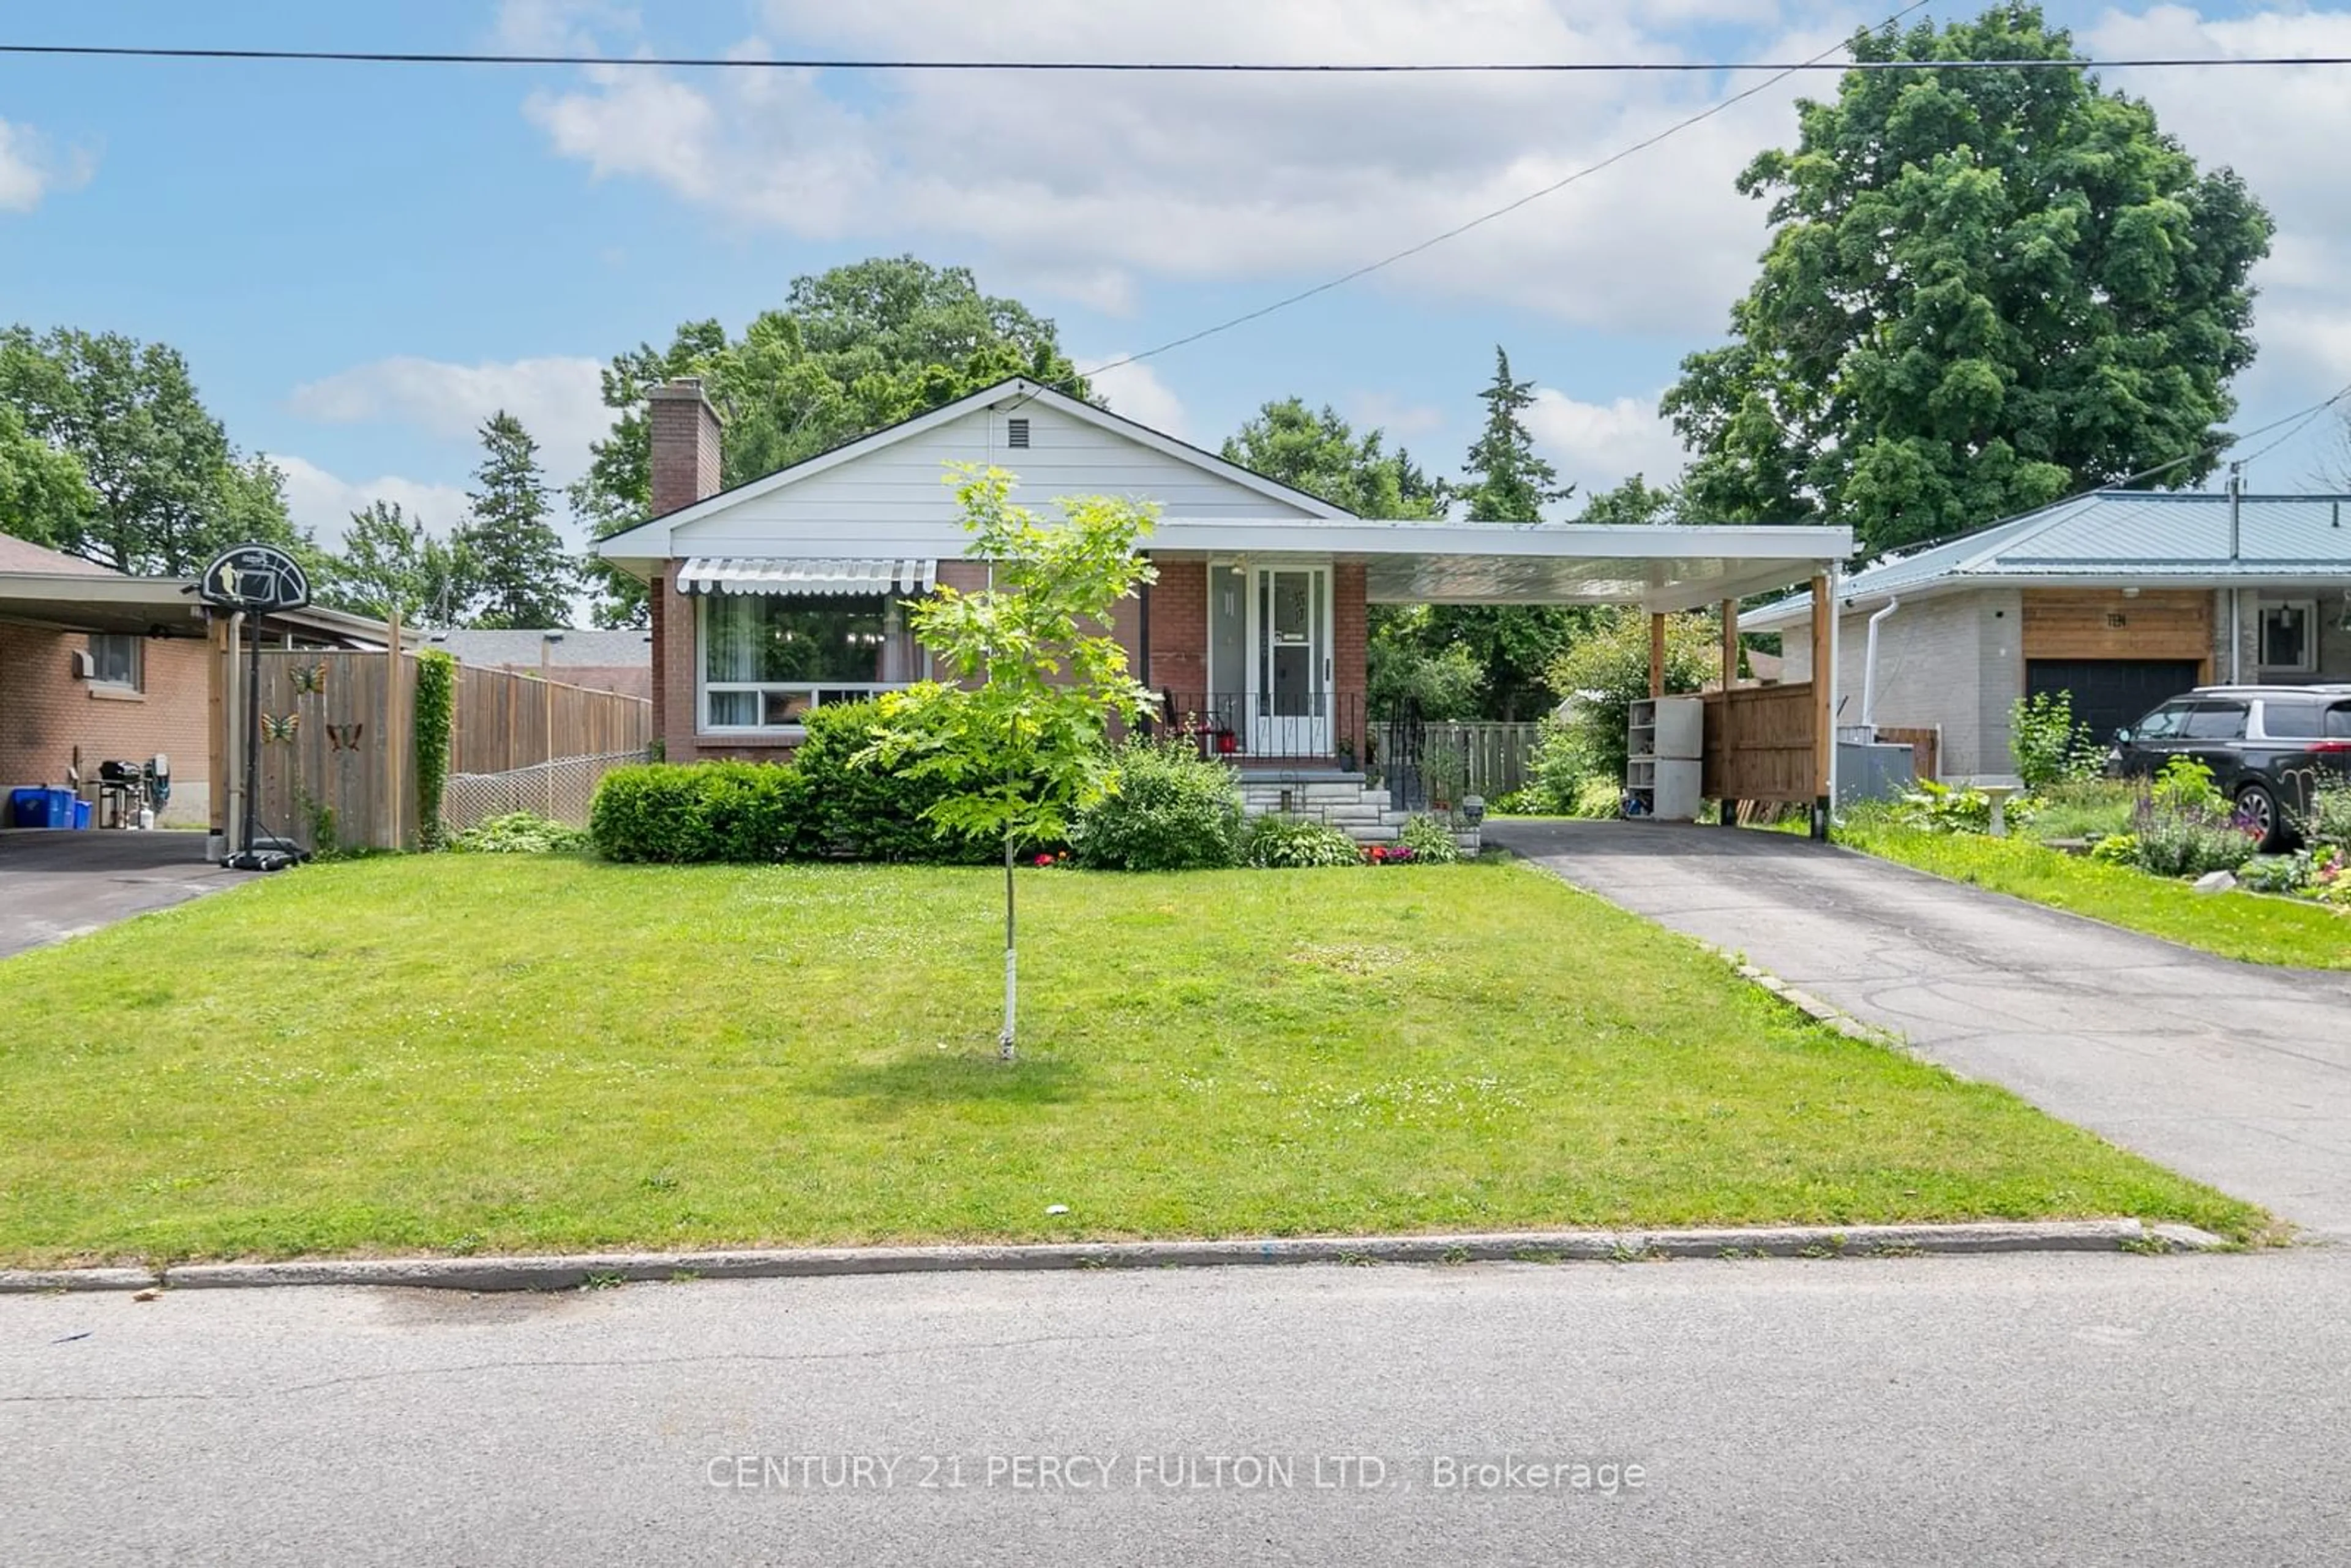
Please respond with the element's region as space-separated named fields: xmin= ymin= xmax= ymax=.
xmin=0 ymin=0 xmax=2351 ymax=552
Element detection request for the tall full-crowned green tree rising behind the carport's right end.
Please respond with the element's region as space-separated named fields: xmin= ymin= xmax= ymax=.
xmin=1665 ymin=5 xmax=2271 ymax=550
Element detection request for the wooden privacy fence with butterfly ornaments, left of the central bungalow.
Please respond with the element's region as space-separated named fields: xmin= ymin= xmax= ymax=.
xmin=250 ymin=649 xmax=654 ymax=849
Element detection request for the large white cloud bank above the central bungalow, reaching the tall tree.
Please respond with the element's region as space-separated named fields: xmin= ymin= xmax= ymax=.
xmin=527 ymin=0 xmax=1858 ymax=331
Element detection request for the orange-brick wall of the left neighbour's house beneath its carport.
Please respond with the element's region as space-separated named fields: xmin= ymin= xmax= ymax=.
xmin=0 ymin=625 xmax=212 ymax=825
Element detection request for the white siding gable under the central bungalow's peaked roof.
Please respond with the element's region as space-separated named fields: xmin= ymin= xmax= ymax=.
xmin=670 ymin=397 xmax=1314 ymax=555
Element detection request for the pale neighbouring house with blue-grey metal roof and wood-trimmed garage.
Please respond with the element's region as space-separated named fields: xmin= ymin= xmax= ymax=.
xmin=1744 ymin=491 xmax=2351 ymax=778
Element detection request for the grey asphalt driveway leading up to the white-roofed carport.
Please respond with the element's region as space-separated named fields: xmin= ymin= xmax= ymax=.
xmin=1486 ymin=820 xmax=2351 ymax=1237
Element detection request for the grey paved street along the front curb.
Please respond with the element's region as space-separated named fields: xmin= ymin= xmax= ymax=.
xmin=0 ymin=1248 xmax=2351 ymax=1568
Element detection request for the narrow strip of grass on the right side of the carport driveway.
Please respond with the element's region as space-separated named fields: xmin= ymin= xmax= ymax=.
xmin=1836 ymin=818 xmax=2351 ymax=969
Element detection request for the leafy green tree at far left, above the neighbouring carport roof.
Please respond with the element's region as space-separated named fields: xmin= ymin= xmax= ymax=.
xmin=0 ymin=327 xmax=306 ymax=576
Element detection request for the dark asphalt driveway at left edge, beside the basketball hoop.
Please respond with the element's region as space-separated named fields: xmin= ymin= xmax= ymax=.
xmin=0 ymin=828 xmax=249 ymax=959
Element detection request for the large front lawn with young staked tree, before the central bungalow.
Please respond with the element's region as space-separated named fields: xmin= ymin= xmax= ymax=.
xmin=0 ymin=856 xmax=2264 ymax=1262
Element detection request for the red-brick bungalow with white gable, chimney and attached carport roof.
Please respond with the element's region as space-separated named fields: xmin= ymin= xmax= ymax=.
xmin=599 ymin=378 xmax=1853 ymax=818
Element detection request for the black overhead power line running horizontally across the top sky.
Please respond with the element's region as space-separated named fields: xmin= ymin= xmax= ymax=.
xmin=13 ymin=45 xmax=2351 ymax=80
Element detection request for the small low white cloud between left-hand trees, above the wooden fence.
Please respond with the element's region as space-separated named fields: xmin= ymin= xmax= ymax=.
xmin=291 ymin=355 xmax=613 ymax=487
